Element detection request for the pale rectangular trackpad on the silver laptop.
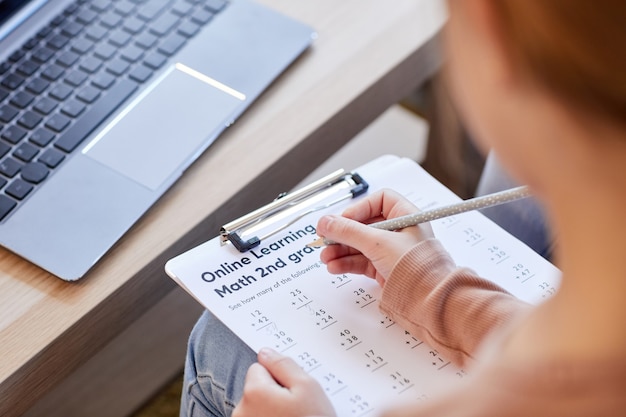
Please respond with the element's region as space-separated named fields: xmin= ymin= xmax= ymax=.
xmin=83 ymin=64 xmax=245 ymax=190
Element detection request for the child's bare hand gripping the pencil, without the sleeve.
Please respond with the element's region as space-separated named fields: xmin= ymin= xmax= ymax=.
xmin=317 ymin=190 xmax=433 ymax=286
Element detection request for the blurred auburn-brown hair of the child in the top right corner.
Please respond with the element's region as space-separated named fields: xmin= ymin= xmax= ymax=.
xmin=491 ymin=0 xmax=626 ymax=124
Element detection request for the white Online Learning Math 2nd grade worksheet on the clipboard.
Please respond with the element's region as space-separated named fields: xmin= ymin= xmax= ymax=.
xmin=166 ymin=156 xmax=560 ymax=416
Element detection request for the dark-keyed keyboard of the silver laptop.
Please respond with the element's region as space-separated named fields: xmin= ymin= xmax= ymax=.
xmin=0 ymin=0 xmax=227 ymax=221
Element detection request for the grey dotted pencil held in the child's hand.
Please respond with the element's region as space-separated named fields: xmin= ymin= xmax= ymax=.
xmin=307 ymin=185 xmax=530 ymax=248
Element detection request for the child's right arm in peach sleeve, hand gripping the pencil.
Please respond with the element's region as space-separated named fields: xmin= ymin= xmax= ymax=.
xmin=317 ymin=190 xmax=529 ymax=365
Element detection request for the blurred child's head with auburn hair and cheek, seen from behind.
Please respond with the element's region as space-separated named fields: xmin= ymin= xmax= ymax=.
xmin=446 ymin=0 xmax=626 ymax=188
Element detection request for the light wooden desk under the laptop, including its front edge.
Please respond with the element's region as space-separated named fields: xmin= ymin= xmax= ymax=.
xmin=0 ymin=0 xmax=445 ymax=416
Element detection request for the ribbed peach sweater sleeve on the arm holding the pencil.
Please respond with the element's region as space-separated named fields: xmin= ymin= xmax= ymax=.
xmin=380 ymin=239 xmax=530 ymax=366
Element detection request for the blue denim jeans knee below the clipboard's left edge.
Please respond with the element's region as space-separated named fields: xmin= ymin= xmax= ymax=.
xmin=180 ymin=311 xmax=256 ymax=417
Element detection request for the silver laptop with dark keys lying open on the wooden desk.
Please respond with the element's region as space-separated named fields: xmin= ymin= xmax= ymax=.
xmin=0 ymin=0 xmax=314 ymax=281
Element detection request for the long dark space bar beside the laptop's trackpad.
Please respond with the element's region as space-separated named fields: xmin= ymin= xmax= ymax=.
xmin=54 ymin=80 xmax=137 ymax=153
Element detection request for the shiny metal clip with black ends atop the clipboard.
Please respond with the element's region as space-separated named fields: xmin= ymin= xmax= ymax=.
xmin=220 ymin=169 xmax=369 ymax=252
